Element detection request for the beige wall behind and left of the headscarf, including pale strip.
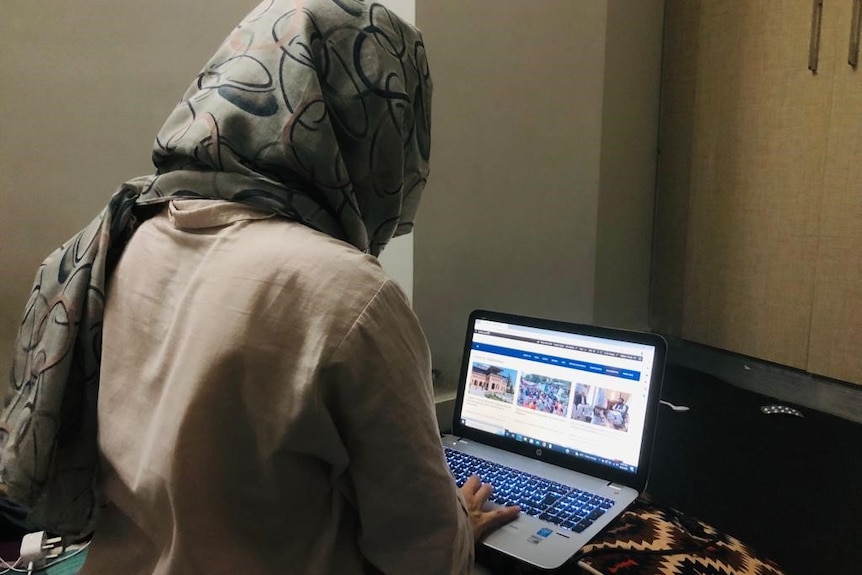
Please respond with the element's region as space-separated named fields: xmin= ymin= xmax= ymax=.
xmin=0 ymin=0 xmax=415 ymax=371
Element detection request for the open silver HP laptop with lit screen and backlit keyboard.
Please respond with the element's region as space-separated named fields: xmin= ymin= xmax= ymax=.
xmin=442 ymin=310 xmax=667 ymax=569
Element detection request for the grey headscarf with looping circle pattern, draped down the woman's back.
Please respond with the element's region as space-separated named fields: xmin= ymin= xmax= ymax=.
xmin=0 ymin=0 xmax=431 ymax=534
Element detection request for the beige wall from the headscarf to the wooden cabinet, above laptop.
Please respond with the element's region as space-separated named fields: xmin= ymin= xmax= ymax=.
xmin=414 ymin=0 xmax=663 ymax=389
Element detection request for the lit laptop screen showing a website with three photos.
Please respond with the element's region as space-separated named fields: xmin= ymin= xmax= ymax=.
xmin=456 ymin=316 xmax=661 ymax=480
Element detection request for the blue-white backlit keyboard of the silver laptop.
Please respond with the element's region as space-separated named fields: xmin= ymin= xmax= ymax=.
xmin=444 ymin=447 xmax=614 ymax=533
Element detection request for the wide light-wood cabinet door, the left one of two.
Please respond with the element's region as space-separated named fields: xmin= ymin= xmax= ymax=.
xmin=683 ymin=0 xmax=844 ymax=368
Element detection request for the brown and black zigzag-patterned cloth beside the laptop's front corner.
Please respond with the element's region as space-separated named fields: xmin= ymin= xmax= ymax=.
xmin=581 ymin=500 xmax=784 ymax=575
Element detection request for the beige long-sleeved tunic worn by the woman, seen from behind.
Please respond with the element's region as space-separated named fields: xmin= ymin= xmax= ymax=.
xmin=82 ymin=200 xmax=473 ymax=575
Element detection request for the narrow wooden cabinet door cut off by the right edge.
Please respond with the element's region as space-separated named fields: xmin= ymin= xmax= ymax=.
xmin=808 ymin=1 xmax=862 ymax=384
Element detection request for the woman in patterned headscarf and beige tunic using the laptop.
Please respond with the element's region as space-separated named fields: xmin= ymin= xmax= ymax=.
xmin=0 ymin=0 xmax=517 ymax=575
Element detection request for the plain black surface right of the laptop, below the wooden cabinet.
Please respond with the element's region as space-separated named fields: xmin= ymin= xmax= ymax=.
xmin=647 ymin=365 xmax=862 ymax=575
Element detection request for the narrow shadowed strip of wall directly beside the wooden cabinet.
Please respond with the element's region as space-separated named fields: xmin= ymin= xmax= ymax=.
xmin=593 ymin=0 xmax=664 ymax=329
